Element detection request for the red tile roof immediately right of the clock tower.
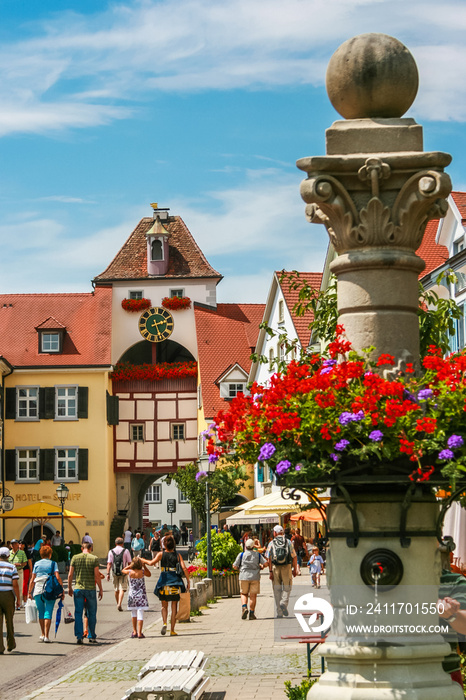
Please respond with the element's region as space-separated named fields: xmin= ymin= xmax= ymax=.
xmin=194 ymin=304 xmax=265 ymax=419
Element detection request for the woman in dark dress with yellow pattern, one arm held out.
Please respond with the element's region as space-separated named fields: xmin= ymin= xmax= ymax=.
xmin=143 ymin=535 xmax=189 ymax=637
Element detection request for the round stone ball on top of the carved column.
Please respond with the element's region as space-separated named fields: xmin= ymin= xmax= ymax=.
xmin=326 ymin=34 xmax=419 ymax=119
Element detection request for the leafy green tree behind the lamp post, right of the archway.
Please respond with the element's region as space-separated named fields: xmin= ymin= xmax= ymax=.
xmin=173 ymin=462 xmax=249 ymax=525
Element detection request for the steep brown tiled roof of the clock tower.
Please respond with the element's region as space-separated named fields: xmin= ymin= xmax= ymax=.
xmin=94 ymin=216 xmax=222 ymax=282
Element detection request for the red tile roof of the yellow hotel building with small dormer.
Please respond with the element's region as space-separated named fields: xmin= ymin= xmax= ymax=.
xmin=0 ymin=287 xmax=112 ymax=367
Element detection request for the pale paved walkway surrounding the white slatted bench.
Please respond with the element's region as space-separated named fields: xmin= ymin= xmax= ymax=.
xmin=25 ymin=570 xmax=320 ymax=700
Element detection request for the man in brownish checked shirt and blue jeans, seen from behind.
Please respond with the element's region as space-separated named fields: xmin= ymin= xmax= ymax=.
xmin=68 ymin=543 xmax=104 ymax=644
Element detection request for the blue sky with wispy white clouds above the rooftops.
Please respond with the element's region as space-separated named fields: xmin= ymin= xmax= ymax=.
xmin=0 ymin=0 xmax=466 ymax=303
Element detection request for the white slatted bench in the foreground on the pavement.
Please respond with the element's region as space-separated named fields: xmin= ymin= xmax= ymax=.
xmin=123 ymin=650 xmax=210 ymax=700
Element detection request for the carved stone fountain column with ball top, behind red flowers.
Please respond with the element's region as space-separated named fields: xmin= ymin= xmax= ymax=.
xmin=298 ymin=34 xmax=463 ymax=700
